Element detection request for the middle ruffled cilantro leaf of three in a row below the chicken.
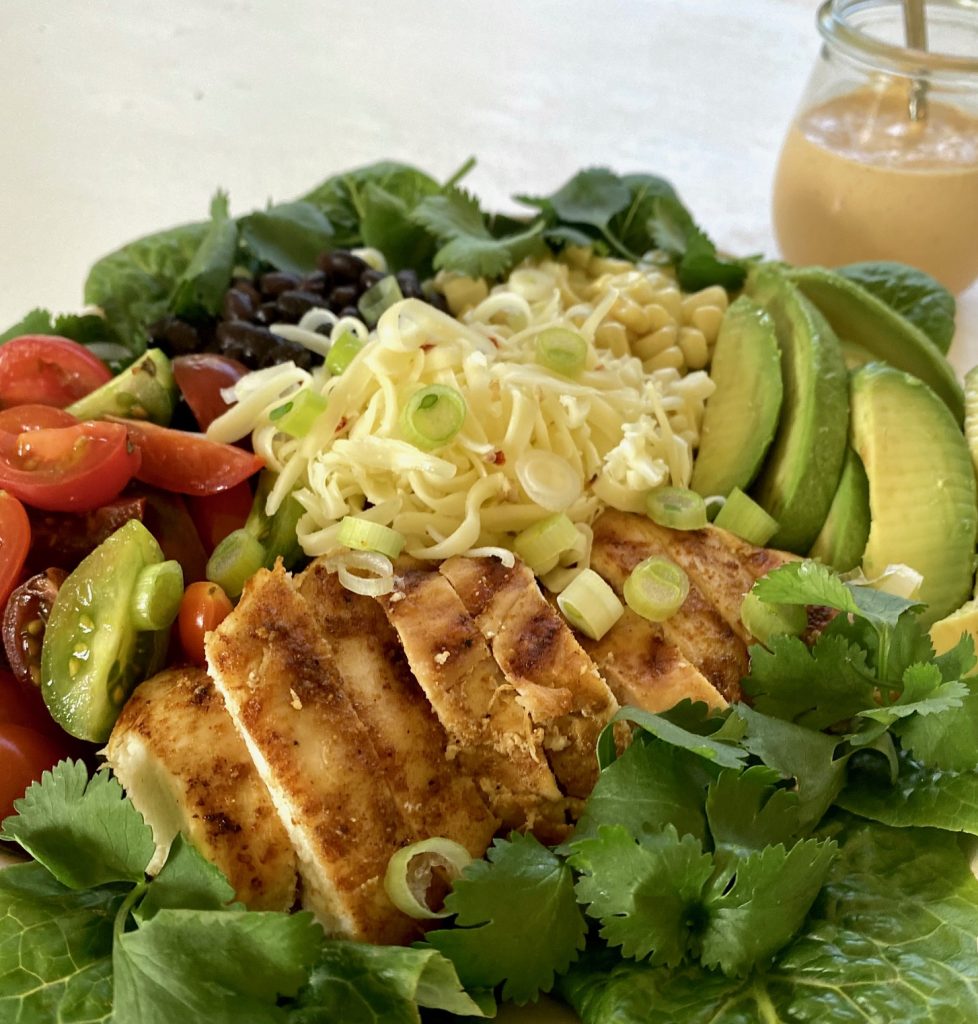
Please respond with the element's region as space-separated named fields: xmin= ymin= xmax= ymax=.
xmin=570 ymin=825 xmax=714 ymax=966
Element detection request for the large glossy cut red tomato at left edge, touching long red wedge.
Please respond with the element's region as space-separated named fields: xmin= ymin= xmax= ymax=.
xmin=0 ymin=422 xmax=139 ymax=512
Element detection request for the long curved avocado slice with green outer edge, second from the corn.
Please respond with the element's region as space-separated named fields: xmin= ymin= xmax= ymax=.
xmin=748 ymin=267 xmax=849 ymax=554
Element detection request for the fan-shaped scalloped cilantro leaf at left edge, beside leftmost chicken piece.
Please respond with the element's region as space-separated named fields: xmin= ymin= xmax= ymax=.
xmin=0 ymin=761 xmax=156 ymax=889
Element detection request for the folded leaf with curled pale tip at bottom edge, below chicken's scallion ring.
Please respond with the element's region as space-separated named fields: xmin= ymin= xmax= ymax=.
xmin=289 ymin=941 xmax=495 ymax=1024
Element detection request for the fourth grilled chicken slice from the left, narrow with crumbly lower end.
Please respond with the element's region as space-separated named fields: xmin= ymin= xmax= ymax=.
xmin=379 ymin=570 xmax=567 ymax=839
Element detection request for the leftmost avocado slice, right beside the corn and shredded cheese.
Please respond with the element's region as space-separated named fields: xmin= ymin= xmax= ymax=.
xmin=689 ymin=295 xmax=783 ymax=496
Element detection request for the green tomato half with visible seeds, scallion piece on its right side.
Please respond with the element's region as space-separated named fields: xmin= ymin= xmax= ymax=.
xmin=41 ymin=519 xmax=168 ymax=742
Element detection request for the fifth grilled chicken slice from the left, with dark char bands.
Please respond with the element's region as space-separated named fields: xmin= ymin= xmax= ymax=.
xmin=440 ymin=558 xmax=618 ymax=800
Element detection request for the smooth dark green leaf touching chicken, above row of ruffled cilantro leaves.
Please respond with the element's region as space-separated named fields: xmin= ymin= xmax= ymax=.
xmin=568 ymin=732 xmax=713 ymax=846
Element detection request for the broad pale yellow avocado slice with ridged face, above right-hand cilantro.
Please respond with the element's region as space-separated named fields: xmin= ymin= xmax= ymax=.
xmin=851 ymin=362 xmax=978 ymax=626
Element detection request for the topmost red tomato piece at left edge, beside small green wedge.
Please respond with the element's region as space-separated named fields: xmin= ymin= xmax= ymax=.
xmin=0 ymin=334 xmax=112 ymax=409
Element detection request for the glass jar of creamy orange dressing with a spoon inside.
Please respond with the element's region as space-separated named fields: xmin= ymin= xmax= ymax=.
xmin=773 ymin=0 xmax=978 ymax=292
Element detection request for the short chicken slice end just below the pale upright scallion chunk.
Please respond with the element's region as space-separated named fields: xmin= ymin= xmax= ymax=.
xmin=580 ymin=608 xmax=727 ymax=712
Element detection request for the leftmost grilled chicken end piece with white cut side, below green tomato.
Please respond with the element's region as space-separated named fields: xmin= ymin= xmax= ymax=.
xmin=105 ymin=669 xmax=296 ymax=910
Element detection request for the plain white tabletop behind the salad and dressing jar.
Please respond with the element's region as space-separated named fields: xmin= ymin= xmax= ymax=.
xmin=0 ymin=0 xmax=978 ymax=1019
